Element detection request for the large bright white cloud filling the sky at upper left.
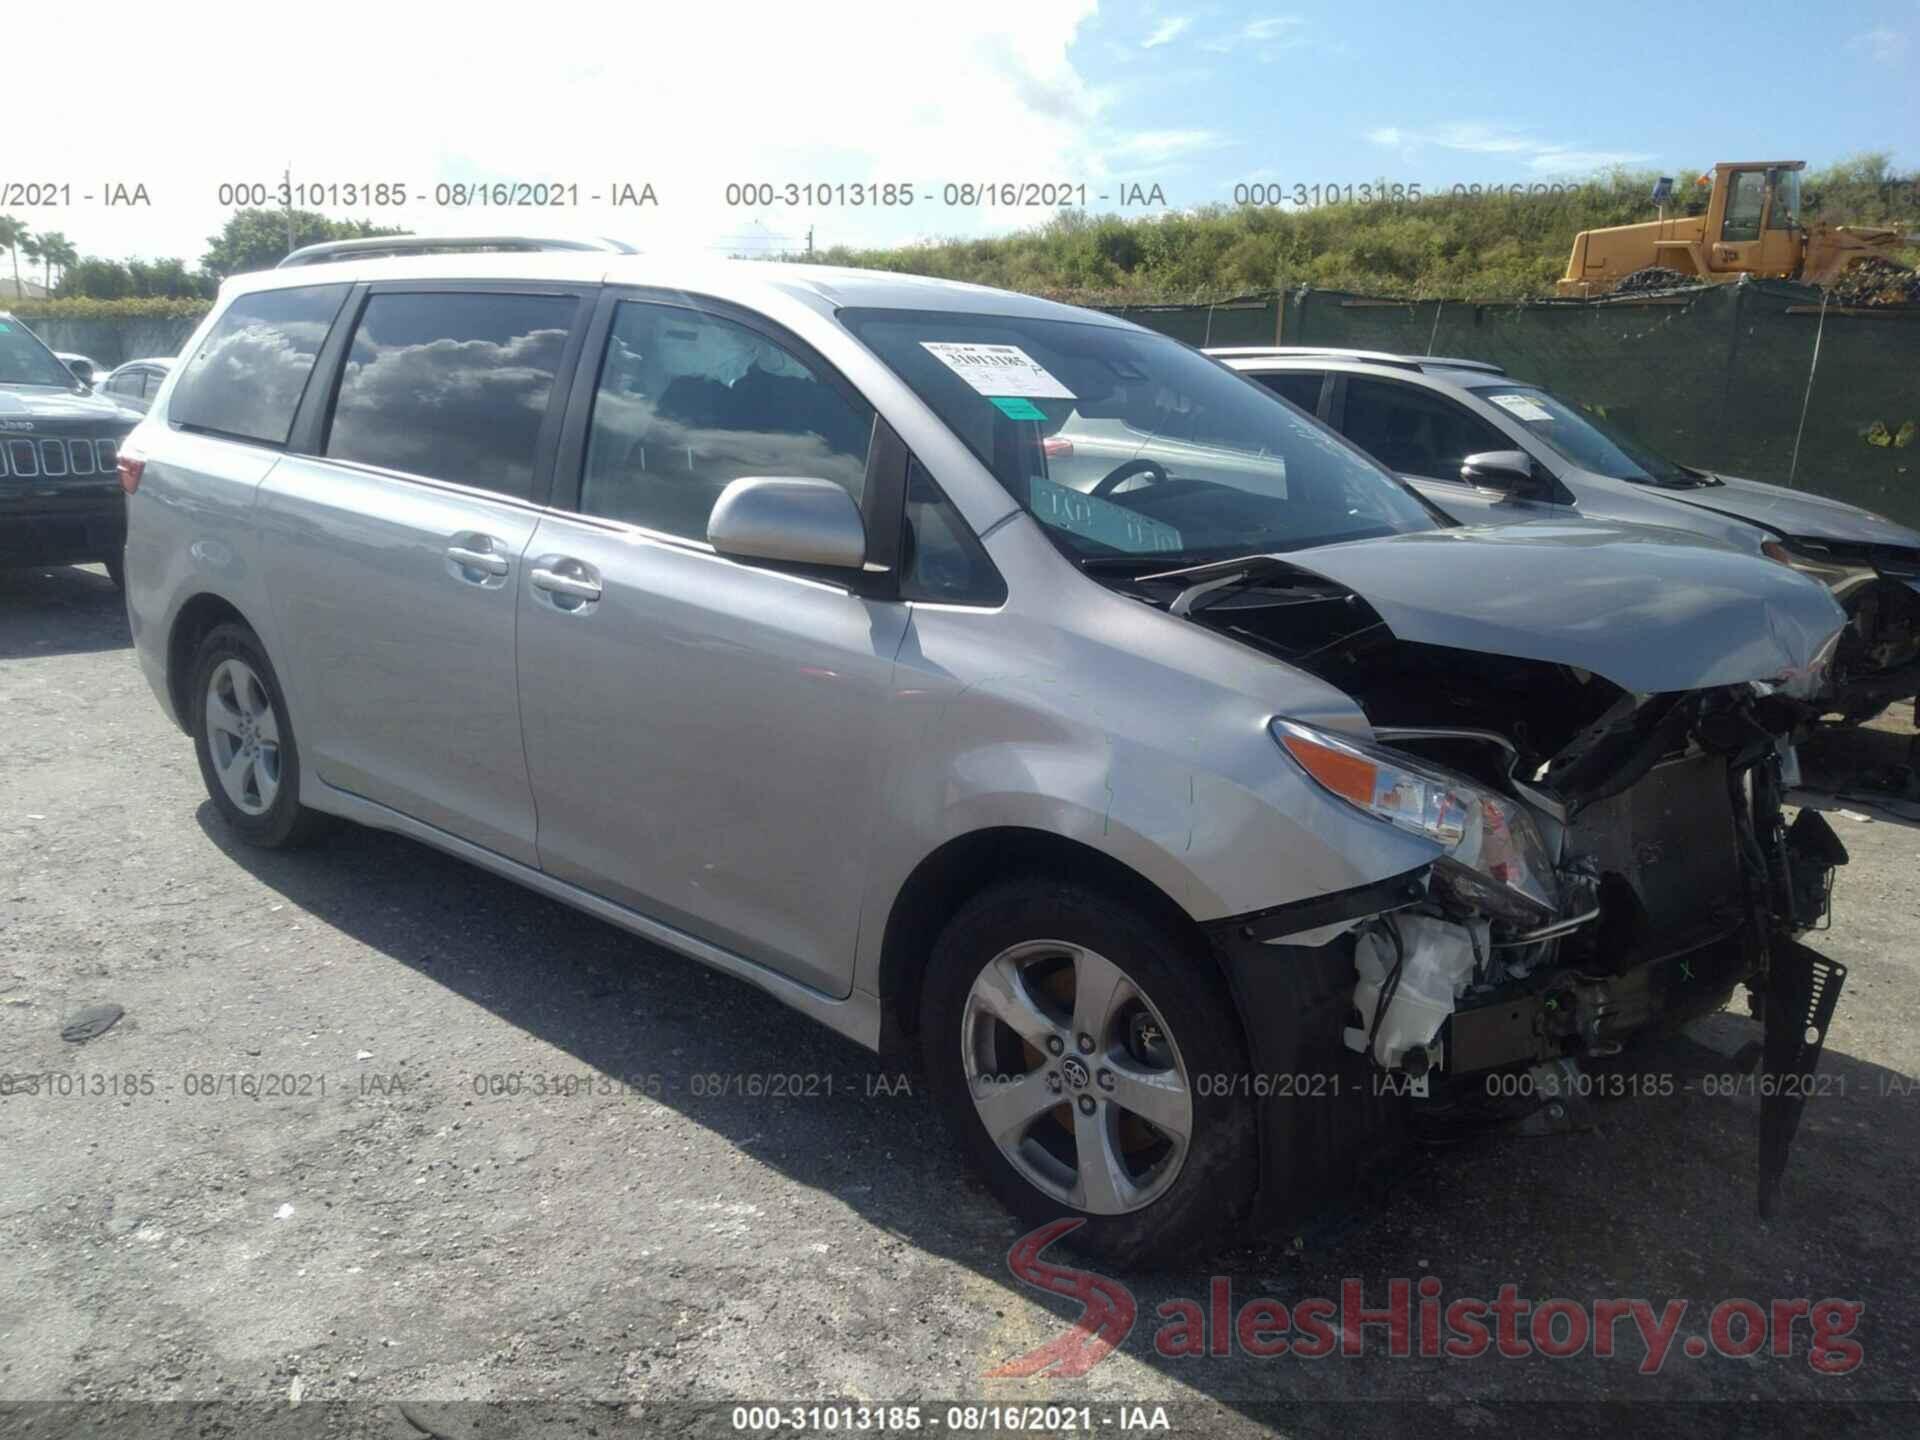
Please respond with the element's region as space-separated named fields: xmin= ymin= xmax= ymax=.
xmin=6 ymin=0 xmax=1113 ymax=263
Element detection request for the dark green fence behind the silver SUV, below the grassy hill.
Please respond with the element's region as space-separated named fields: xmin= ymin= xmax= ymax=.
xmin=1112 ymin=280 xmax=1920 ymax=528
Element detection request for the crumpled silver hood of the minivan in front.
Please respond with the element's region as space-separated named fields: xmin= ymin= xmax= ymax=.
xmin=1273 ymin=522 xmax=1847 ymax=695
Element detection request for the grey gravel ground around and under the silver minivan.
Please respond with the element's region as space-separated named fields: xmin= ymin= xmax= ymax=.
xmin=0 ymin=568 xmax=1920 ymax=1436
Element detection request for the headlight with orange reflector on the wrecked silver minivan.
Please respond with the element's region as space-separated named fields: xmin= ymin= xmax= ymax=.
xmin=1269 ymin=718 xmax=1559 ymax=924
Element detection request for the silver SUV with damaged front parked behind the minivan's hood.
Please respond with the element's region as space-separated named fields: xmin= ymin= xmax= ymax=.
xmin=1208 ymin=348 xmax=1920 ymax=722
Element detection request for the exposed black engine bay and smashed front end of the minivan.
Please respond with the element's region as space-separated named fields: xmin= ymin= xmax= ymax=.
xmin=1127 ymin=557 xmax=1847 ymax=1213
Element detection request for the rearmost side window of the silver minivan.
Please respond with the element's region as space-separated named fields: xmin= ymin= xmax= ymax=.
xmin=167 ymin=284 xmax=348 ymax=445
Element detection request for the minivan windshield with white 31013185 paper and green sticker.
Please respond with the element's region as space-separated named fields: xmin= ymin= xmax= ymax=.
xmin=839 ymin=309 xmax=1440 ymax=564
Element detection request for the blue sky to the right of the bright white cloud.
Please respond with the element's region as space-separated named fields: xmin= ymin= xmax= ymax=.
xmin=1069 ymin=0 xmax=1920 ymax=204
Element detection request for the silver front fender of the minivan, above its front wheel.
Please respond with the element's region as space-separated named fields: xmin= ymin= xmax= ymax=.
xmin=854 ymin=520 xmax=1438 ymax=989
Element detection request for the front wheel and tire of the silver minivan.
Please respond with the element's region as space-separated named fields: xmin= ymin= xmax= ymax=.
xmin=920 ymin=879 xmax=1258 ymax=1263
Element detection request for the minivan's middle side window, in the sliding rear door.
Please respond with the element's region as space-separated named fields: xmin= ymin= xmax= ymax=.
xmin=326 ymin=292 xmax=580 ymax=497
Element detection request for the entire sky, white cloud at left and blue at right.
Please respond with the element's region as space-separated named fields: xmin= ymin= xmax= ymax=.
xmin=0 ymin=0 xmax=1920 ymax=263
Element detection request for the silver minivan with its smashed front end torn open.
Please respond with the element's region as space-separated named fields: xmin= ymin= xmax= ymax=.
xmin=121 ymin=240 xmax=1845 ymax=1260
